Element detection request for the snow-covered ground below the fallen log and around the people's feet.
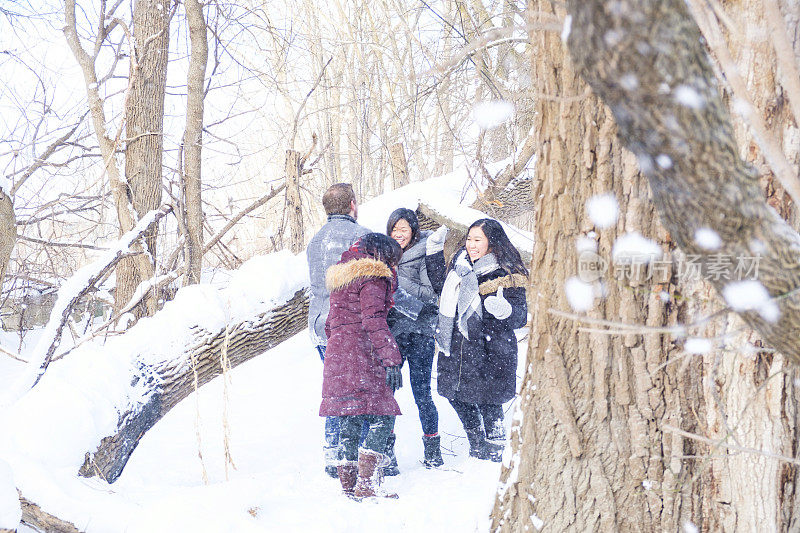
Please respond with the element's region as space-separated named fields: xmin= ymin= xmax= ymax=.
xmin=4 ymin=324 xmax=525 ymax=532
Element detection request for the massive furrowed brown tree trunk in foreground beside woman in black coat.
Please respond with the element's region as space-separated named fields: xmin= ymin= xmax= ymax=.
xmin=491 ymin=0 xmax=688 ymax=531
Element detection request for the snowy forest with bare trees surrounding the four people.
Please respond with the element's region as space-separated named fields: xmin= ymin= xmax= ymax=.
xmin=0 ymin=0 xmax=800 ymax=533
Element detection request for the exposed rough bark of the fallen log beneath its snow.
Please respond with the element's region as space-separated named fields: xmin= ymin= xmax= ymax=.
xmin=79 ymin=289 xmax=308 ymax=483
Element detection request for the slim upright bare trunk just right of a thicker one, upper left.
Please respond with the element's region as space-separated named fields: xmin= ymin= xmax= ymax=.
xmin=183 ymin=0 xmax=208 ymax=284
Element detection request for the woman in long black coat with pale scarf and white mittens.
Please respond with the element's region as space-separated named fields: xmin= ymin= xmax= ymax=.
xmin=436 ymin=218 xmax=528 ymax=461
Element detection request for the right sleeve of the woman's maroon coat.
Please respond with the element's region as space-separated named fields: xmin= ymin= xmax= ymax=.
xmin=359 ymin=278 xmax=403 ymax=366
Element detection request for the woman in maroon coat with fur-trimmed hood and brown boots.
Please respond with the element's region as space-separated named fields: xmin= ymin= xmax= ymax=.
xmin=319 ymin=233 xmax=402 ymax=498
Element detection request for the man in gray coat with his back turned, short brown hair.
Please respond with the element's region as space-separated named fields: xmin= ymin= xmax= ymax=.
xmin=306 ymin=183 xmax=370 ymax=477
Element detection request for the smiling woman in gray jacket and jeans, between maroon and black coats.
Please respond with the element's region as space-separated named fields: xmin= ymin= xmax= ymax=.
xmin=386 ymin=208 xmax=444 ymax=467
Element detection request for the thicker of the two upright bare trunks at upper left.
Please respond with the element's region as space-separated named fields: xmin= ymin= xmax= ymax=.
xmin=119 ymin=0 xmax=172 ymax=316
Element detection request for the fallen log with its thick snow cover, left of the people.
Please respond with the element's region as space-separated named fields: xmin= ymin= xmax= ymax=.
xmin=0 ymin=247 xmax=308 ymax=488
